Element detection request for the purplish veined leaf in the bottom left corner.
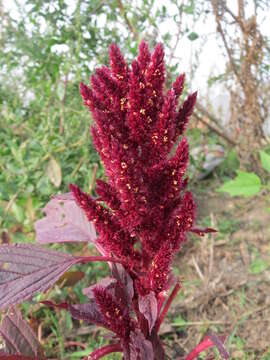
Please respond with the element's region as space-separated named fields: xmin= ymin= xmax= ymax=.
xmin=0 ymin=308 xmax=45 ymax=359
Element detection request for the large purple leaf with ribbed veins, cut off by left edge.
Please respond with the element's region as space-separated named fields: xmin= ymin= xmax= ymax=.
xmin=0 ymin=244 xmax=78 ymax=309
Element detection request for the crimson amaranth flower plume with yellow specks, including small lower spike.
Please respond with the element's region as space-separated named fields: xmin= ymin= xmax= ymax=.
xmin=70 ymin=41 xmax=213 ymax=359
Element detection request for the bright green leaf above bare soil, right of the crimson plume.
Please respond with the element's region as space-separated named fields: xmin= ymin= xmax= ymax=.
xmin=217 ymin=170 xmax=261 ymax=197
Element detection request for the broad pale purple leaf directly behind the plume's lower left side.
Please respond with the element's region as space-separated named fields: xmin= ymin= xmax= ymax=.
xmin=35 ymin=193 xmax=96 ymax=244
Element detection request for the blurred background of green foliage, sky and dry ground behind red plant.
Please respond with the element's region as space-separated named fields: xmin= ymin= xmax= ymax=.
xmin=0 ymin=0 xmax=270 ymax=360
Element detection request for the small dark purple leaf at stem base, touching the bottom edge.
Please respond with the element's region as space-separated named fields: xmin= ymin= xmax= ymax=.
xmin=130 ymin=329 xmax=154 ymax=360
